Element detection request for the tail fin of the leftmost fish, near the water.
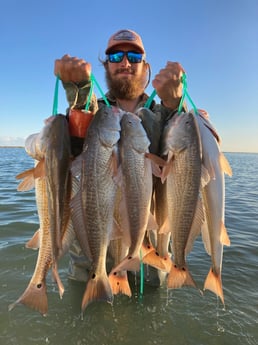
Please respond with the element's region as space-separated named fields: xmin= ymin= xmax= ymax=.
xmin=8 ymin=281 xmax=48 ymax=316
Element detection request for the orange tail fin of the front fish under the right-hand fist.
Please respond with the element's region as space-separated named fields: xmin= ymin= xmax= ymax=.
xmin=167 ymin=262 xmax=197 ymax=289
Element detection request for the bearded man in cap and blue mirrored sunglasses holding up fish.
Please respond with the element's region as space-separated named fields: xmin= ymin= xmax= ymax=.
xmin=52 ymin=30 xmax=184 ymax=286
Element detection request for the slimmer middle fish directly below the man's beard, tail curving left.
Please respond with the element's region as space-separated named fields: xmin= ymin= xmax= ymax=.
xmin=111 ymin=113 xmax=152 ymax=274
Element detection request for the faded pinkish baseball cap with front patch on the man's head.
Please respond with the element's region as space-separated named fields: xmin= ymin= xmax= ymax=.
xmin=105 ymin=29 xmax=145 ymax=54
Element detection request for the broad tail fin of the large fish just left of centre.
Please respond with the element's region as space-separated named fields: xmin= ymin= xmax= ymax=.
xmin=81 ymin=274 xmax=113 ymax=312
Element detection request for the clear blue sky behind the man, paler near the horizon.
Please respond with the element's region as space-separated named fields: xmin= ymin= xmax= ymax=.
xmin=0 ymin=0 xmax=258 ymax=152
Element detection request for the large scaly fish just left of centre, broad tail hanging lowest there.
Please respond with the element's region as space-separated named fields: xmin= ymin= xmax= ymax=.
xmin=71 ymin=108 xmax=121 ymax=311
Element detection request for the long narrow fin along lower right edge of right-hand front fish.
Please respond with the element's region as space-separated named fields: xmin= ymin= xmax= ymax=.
xmin=185 ymin=198 xmax=204 ymax=255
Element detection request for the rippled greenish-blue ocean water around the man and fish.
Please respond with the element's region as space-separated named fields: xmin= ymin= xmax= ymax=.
xmin=0 ymin=148 xmax=258 ymax=345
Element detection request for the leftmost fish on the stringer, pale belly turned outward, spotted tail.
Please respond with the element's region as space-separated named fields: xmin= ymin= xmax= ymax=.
xmin=9 ymin=115 xmax=74 ymax=315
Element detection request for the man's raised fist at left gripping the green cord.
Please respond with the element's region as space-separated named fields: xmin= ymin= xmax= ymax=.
xmin=54 ymin=54 xmax=91 ymax=83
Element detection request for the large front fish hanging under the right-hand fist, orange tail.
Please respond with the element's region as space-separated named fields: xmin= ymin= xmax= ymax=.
xmin=163 ymin=113 xmax=201 ymax=288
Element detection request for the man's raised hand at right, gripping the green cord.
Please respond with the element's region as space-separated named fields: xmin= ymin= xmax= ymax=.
xmin=152 ymin=61 xmax=185 ymax=109
